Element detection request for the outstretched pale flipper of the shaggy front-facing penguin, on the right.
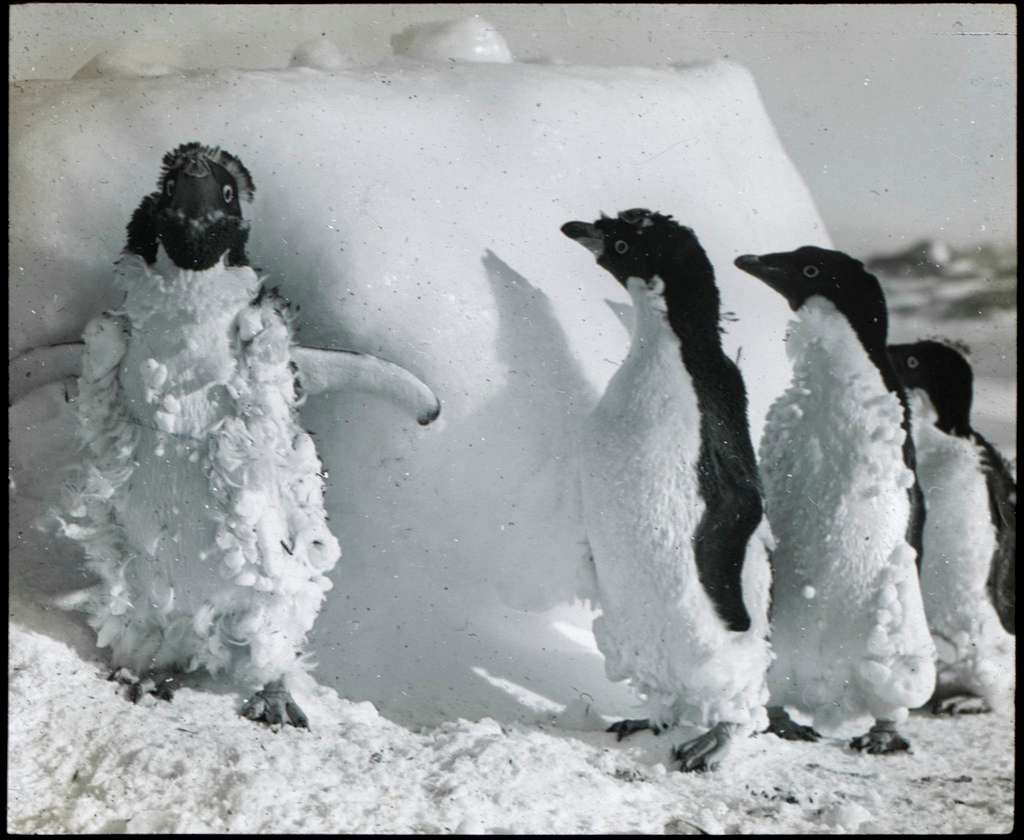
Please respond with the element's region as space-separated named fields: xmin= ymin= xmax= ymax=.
xmin=292 ymin=345 xmax=441 ymax=426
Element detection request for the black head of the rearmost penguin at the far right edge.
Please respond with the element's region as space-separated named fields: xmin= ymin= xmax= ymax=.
xmin=889 ymin=339 xmax=974 ymax=437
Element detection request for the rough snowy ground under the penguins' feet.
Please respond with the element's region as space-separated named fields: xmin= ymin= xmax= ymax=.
xmin=7 ymin=614 xmax=1015 ymax=834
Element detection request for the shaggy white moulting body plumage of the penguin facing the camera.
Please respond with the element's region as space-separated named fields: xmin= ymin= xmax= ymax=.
xmin=58 ymin=256 xmax=340 ymax=686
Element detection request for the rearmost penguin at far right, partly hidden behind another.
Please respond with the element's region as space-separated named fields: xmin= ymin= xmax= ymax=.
xmin=889 ymin=340 xmax=1017 ymax=714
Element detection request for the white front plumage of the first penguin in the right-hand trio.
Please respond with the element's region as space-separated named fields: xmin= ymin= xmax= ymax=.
xmin=581 ymin=278 xmax=771 ymax=734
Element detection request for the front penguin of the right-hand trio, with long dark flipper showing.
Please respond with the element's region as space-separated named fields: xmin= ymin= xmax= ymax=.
xmin=561 ymin=209 xmax=771 ymax=770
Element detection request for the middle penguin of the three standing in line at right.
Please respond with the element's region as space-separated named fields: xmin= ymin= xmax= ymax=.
xmin=735 ymin=246 xmax=935 ymax=753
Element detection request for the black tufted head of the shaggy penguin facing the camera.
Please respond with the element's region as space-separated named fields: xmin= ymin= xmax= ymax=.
xmin=153 ymin=142 xmax=255 ymax=271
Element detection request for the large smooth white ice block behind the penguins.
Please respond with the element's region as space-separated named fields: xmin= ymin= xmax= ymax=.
xmin=9 ymin=59 xmax=829 ymax=729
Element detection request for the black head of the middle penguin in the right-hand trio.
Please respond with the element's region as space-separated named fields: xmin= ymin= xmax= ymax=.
xmin=735 ymin=245 xmax=889 ymax=347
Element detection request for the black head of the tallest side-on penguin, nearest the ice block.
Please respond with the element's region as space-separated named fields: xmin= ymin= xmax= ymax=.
xmin=561 ymin=208 xmax=710 ymax=292
